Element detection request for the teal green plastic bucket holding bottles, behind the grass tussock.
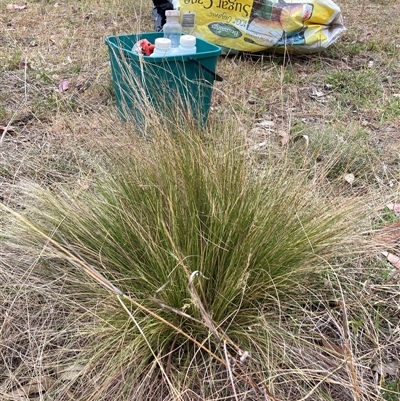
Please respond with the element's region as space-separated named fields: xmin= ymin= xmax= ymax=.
xmin=105 ymin=32 xmax=221 ymax=127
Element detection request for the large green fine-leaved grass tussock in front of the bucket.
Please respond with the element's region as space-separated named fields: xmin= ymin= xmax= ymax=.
xmin=1 ymin=122 xmax=374 ymax=400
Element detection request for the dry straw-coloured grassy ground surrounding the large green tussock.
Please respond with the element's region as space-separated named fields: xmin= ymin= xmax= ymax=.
xmin=0 ymin=0 xmax=400 ymax=401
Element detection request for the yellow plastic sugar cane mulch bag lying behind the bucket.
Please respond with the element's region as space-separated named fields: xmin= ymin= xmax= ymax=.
xmin=174 ymin=0 xmax=345 ymax=53
